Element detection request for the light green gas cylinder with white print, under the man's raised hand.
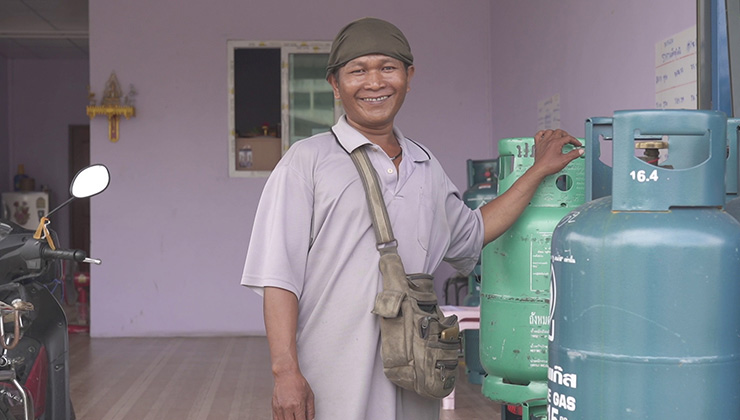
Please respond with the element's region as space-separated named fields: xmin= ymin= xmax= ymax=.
xmin=480 ymin=138 xmax=585 ymax=410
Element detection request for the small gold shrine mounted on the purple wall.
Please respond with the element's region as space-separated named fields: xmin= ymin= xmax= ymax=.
xmin=87 ymin=72 xmax=136 ymax=143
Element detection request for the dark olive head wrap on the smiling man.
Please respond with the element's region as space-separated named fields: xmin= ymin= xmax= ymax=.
xmin=326 ymin=18 xmax=414 ymax=78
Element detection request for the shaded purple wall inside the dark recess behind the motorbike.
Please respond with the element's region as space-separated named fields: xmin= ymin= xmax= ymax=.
xmin=0 ymin=59 xmax=90 ymax=246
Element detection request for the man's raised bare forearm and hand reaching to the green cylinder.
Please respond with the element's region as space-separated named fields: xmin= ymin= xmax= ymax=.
xmin=481 ymin=130 xmax=583 ymax=244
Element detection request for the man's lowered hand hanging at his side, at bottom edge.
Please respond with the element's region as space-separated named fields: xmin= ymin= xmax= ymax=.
xmin=272 ymin=372 xmax=316 ymax=420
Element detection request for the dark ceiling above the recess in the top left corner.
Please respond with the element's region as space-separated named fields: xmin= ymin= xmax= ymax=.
xmin=0 ymin=0 xmax=90 ymax=59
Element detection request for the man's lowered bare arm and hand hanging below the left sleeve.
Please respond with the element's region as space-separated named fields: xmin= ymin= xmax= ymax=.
xmin=264 ymin=287 xmax=315 ymax=420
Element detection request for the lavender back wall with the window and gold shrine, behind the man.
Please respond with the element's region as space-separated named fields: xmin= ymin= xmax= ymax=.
xmin=90 ymin=0 xmax=493 ymax=336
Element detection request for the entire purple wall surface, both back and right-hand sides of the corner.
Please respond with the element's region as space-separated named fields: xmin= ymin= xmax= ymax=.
xmin=90 ymin=0 xmax=695 ymax=336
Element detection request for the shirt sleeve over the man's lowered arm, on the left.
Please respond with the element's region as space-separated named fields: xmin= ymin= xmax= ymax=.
xmin=241 ymin=151 xmax=313 ymax=298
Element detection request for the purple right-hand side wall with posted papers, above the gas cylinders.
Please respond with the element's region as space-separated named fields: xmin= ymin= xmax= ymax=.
xmin=491 ymin=0 xmax=696 ymax=138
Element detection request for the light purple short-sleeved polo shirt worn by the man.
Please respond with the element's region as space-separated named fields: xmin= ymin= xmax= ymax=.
xmin=242 ymin=117 xmax=483 ymax=420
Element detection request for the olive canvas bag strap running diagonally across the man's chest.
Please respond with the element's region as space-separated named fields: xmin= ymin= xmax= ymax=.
xmin=349 ymin=146 xmax=398 ymax=249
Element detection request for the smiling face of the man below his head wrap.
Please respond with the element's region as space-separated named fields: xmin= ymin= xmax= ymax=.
xmin=329 ymin=54 xmax=414 ymax=131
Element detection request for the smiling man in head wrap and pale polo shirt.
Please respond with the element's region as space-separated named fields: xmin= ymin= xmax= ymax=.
xmin=242 ymin=18 xmax=581 ymax=420
